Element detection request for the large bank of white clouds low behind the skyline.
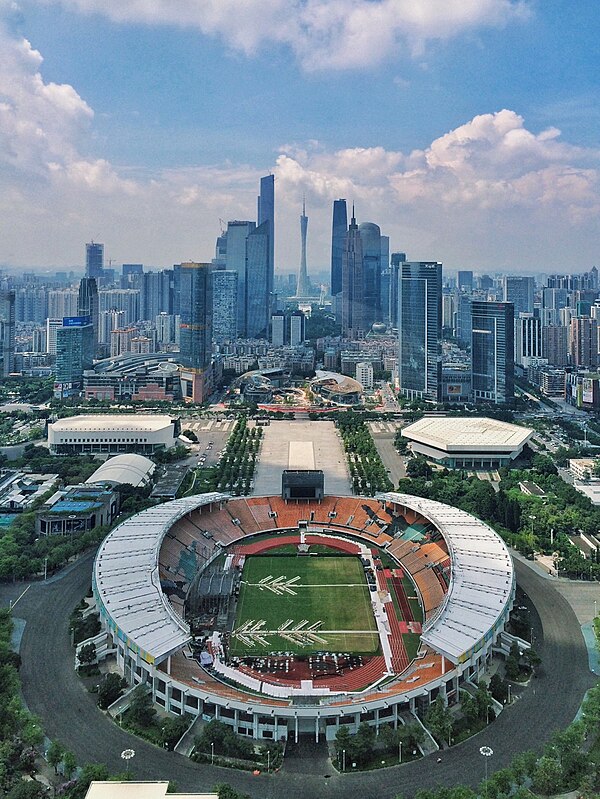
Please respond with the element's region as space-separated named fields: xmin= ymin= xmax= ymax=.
xmin=0 ymin=8 xmax=600 ymax=271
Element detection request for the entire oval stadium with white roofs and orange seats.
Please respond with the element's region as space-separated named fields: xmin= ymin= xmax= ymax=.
xmin=93 ymin=471 xmax=515 ymax=742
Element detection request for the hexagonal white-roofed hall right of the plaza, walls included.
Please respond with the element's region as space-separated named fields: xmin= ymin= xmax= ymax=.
xmin=402 ymin=416 xmax=534 ymax=469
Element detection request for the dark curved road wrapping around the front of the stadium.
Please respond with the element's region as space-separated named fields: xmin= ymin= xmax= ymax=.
xmin=0 ymin=555 xmax=595 ymax=799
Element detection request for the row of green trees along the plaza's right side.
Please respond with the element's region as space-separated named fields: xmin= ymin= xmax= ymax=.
xmin=336 ymin=411 xmax=393 ymax=494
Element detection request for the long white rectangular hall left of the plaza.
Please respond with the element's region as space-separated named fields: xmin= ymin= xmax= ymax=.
xmin=48 ymin=413 xmax=181 ymax=455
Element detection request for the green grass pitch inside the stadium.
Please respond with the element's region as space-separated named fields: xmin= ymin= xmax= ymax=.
xmin=229 ymin=555 xmax=379 ymax=657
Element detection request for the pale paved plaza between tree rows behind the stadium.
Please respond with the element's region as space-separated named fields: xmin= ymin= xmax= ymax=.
xmin=252 ymin=421 xmax=352 ymax=496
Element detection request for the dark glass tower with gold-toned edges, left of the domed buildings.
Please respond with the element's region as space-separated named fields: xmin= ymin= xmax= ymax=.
xmin=178 ymin=262 xmax=212 ymax=402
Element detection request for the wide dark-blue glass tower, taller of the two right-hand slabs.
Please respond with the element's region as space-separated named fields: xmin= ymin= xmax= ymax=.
xmin=398 ymin=261 xmax=442 ymax=402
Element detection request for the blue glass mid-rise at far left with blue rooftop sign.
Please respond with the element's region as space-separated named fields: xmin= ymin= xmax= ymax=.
xmin=54 ymin=316 xmax=95 ymax=398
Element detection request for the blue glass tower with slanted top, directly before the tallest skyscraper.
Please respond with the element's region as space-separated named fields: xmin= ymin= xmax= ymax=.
xmin=245 ymin=221 xmax=272 ymax=338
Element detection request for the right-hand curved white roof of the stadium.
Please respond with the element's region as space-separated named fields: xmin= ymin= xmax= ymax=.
xmin=380 ymin=492 xmax=515 ymax=663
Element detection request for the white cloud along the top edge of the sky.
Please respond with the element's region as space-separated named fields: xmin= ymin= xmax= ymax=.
xmin=38 ymin=0 xmax=529 ymax=70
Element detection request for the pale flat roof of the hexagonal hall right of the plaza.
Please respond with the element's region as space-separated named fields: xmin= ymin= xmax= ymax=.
xmin=402 ymin=416 xmax=534 ymax=452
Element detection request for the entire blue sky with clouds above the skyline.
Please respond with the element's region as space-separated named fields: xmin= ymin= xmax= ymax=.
xmin=0 ymin=0 xmax=600 ymax=271
